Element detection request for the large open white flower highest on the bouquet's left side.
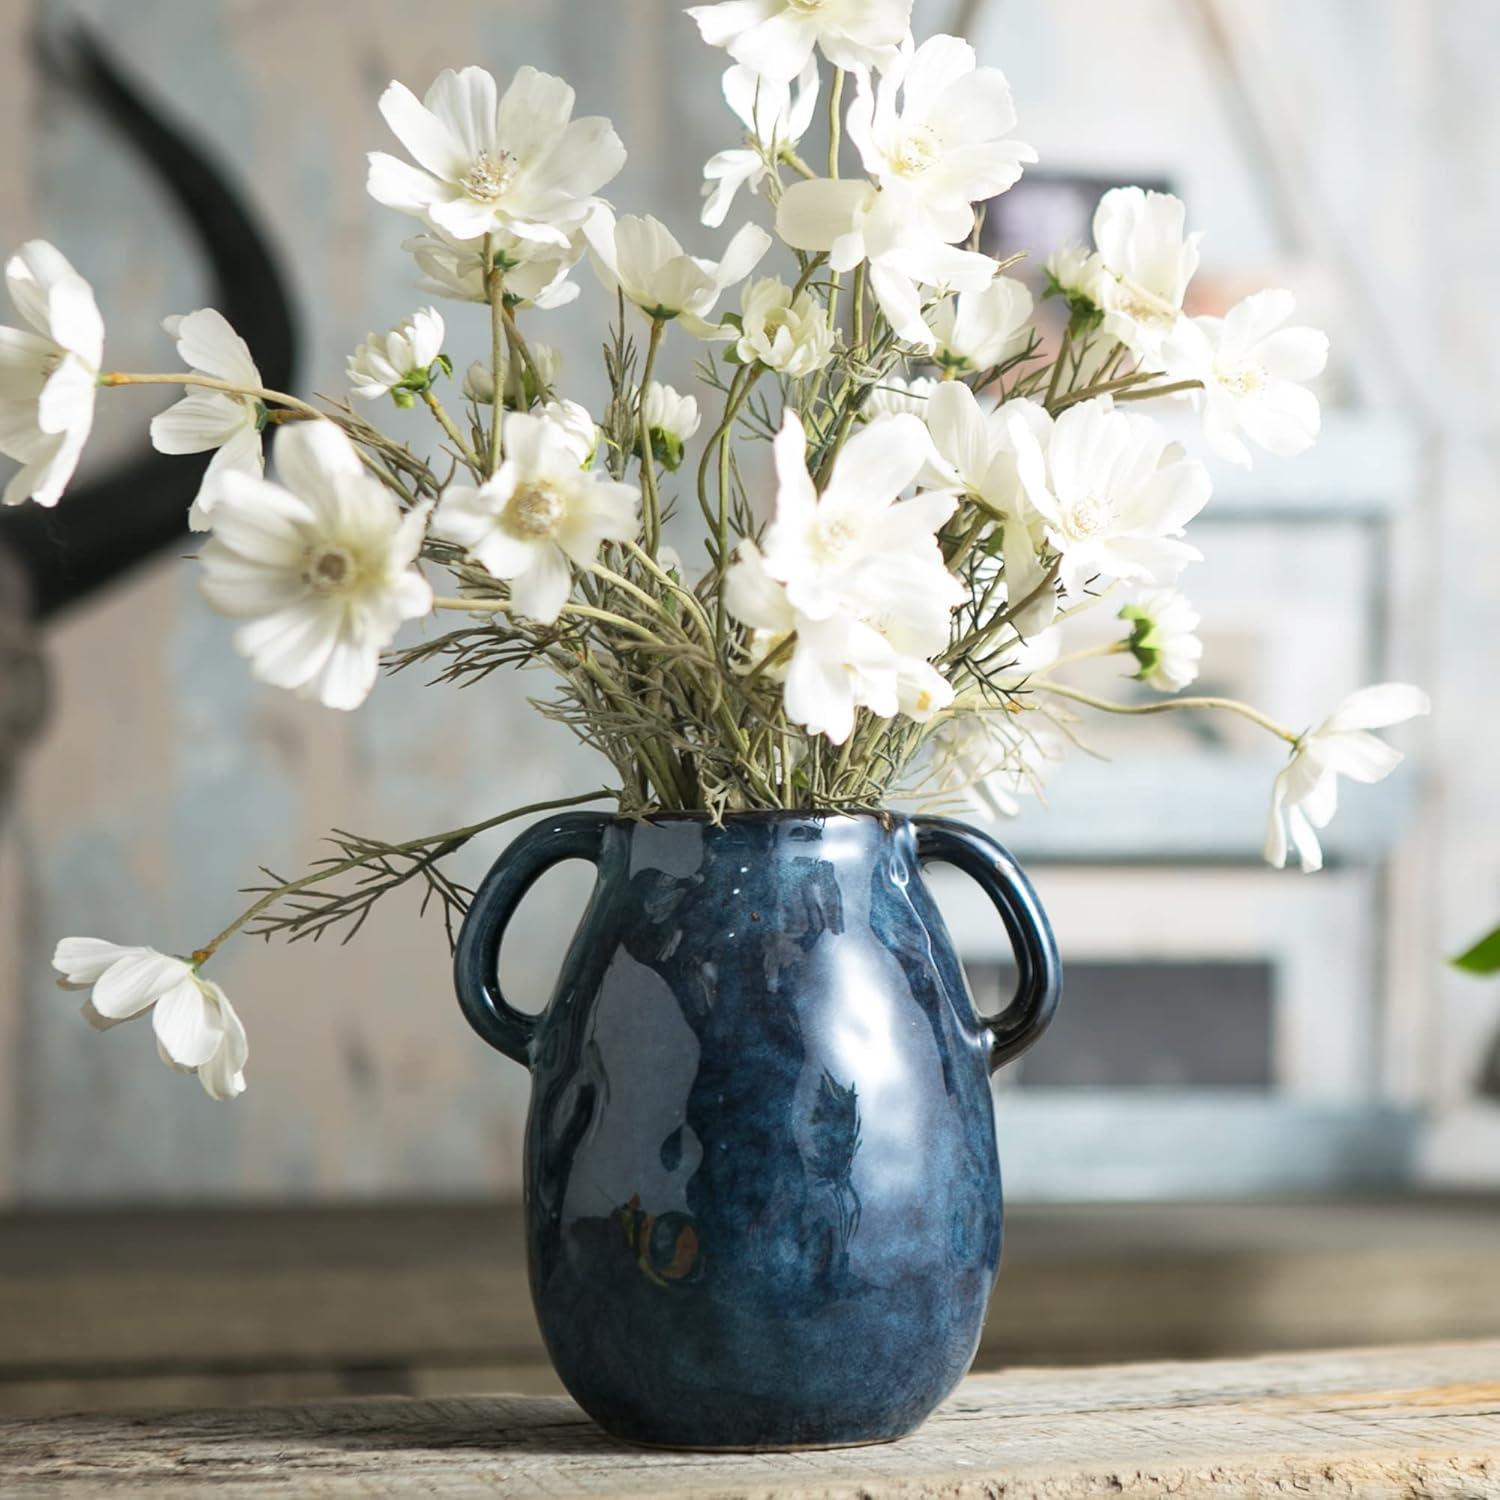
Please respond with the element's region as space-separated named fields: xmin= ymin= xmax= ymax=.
xmin=369 ymin=68 xmax=626 ymax=246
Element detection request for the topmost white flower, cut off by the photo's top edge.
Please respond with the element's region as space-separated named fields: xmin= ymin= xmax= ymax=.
xmin=687 ymin=0 xmax=912 ymax=83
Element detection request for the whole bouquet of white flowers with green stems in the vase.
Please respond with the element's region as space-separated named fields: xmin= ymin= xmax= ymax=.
xmin=20 ymin=0 xmax=1427 ymax=1098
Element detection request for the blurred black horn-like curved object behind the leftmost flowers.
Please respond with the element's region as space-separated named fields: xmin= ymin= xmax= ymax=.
xmin=0 ymin=26 xmax=297 ymax=620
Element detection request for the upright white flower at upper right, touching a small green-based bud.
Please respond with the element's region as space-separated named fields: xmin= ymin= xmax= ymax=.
xmin=1092 ymin=188 xmax=1203 ymax=362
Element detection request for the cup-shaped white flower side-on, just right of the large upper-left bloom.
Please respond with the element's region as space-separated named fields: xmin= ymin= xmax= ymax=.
xmin=584 ymin=207 xmax=771 ymax=338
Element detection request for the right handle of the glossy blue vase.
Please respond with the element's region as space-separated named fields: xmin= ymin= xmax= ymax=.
xmin=912 ymin=818 xmax=1062 ymax=1073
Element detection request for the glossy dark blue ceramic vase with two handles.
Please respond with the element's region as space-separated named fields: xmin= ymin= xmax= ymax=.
xmin=455 ymin=812 xmax=1061 ymax=1449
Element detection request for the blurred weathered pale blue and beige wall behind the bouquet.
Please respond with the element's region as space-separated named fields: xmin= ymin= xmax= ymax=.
xmin=0 ymin=0 xmax=1500 ymax=1203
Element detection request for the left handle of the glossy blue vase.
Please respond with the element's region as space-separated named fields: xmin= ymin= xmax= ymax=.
xmin=453 ymin=813 xmax=609 ymax=1068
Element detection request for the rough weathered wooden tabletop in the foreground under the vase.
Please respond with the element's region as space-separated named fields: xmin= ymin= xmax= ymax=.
xmin=0 ymin=1341 xmax=1500 ymax=1500
